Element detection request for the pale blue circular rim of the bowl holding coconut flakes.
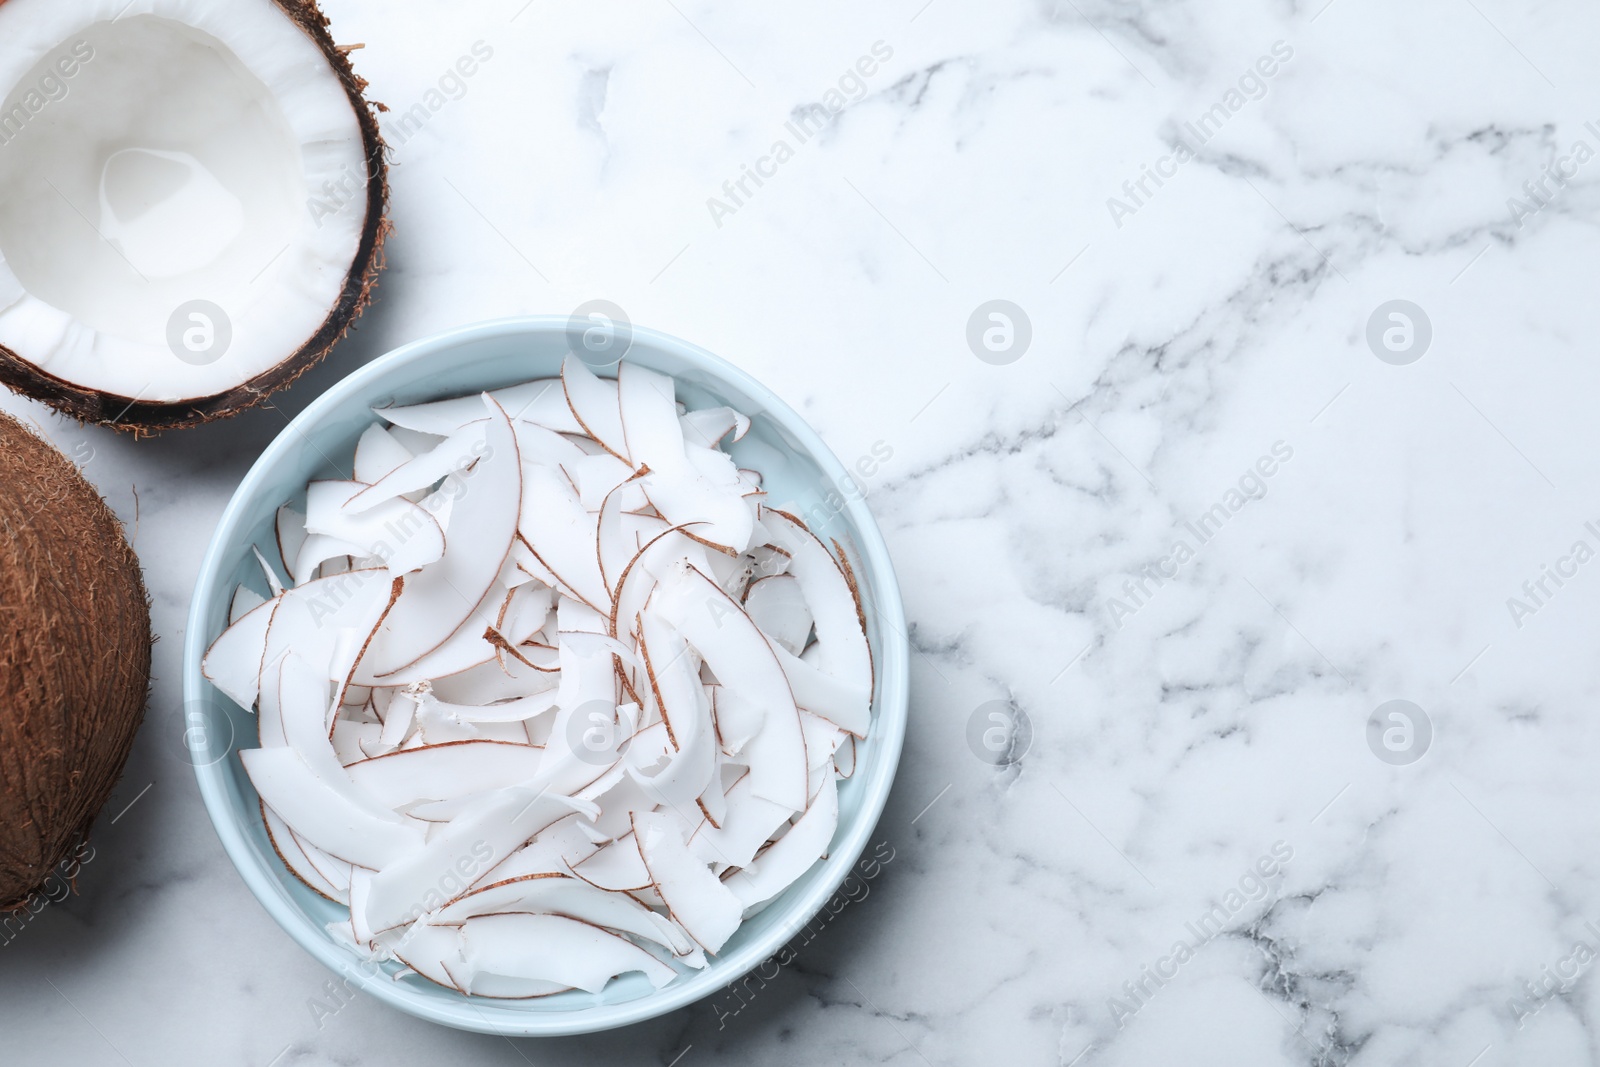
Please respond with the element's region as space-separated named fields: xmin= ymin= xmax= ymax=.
xmin=182 ymin=315 xmax=910 ymax=1037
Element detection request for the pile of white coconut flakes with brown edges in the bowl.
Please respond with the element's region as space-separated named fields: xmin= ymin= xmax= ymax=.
xmin=203 ymin=360 xmax=874 ymax=998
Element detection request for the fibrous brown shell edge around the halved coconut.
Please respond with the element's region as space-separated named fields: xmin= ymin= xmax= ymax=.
xmin=0 ymin=0 xmax=392 ymax=437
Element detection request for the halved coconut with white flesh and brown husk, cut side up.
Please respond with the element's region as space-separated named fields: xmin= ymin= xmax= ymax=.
xmin=0 ymin=0 xmax=387 ymax=434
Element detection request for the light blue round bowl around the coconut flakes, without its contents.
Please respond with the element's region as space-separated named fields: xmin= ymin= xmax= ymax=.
xmin=184 ymin=317 xmax=909 ymax=1035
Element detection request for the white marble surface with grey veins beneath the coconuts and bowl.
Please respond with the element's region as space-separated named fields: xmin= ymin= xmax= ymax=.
xmin=0 ymin=0 xmax=1600 ymax=1067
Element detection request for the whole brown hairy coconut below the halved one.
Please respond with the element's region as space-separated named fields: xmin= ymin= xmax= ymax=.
xmin=0 ymin=414 xmax=150 ymax=913
